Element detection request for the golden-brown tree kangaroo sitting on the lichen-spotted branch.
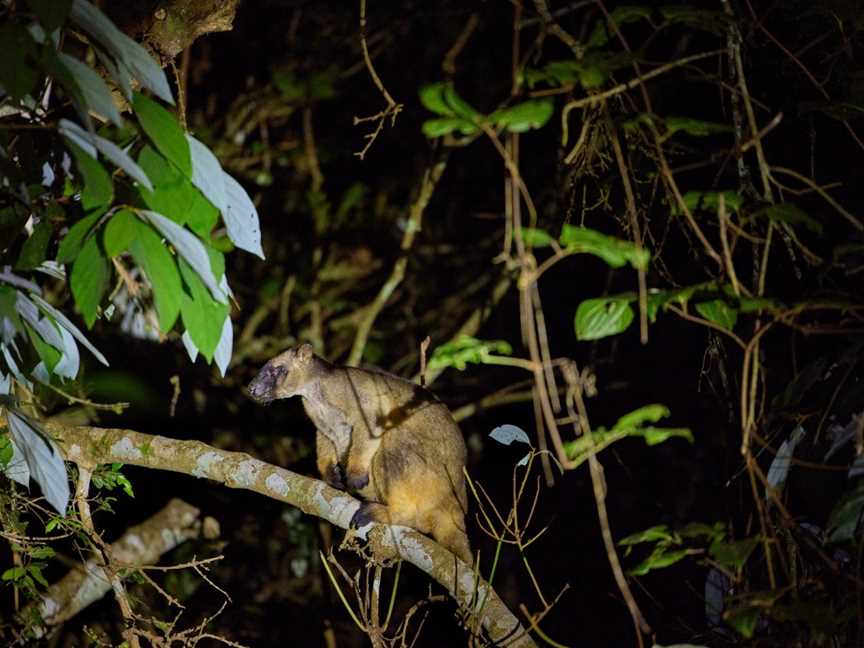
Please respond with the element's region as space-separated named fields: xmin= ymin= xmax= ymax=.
xmin=249 ymin=344 xmax=471 ymax=564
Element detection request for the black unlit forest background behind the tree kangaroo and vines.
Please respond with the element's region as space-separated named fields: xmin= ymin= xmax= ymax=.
xmin=11 ymin=0 xmax=864 ymax=646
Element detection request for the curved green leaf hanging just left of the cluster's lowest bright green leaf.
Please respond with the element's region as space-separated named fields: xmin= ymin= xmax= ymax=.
xmin=129 ymin=222 xmax=183 ymax=333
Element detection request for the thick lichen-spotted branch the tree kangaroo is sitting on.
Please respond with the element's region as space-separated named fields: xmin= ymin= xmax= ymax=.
xmin=46 ymin=424 xmax=535 ymax=648
